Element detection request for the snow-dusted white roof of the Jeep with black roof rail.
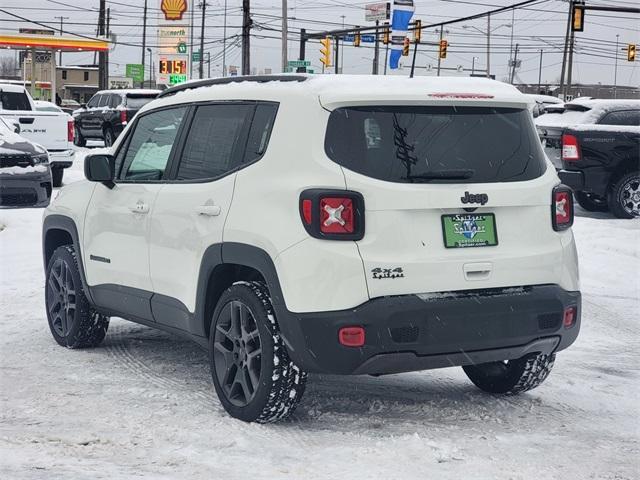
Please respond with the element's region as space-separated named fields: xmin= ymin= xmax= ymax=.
xmin=148 ymin=74 xmax=533 ymax=111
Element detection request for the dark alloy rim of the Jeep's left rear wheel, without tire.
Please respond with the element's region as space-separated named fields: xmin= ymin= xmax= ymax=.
xmin=213 ymin=300 xmax=262 ymax=407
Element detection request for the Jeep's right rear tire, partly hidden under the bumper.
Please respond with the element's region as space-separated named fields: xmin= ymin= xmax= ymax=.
xmin=462 ymin=353 xmax=556 ymax=395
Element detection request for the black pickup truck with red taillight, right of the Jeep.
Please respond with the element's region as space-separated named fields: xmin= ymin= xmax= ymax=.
xmin=537 ymin=99 xmax=640 ymax=218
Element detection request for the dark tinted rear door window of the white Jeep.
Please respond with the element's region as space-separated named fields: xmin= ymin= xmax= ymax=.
xmin=177 ymin=104 xmax=255 ymax=180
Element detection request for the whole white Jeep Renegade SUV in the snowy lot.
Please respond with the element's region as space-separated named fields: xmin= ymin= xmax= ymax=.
xmin=43 ymin=75 xmax=581 ymax=422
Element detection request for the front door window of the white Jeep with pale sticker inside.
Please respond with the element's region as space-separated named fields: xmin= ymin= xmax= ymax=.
xmin=116 ymin=107 xmax=186 ymax=182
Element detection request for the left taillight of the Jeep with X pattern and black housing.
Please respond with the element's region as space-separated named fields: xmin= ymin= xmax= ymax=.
xmin=299 ymin=189 xmax=364 ymax=240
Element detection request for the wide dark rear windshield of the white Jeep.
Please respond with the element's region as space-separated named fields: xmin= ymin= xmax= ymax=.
xmin=325 ymin=106 xmax=546 ymax=183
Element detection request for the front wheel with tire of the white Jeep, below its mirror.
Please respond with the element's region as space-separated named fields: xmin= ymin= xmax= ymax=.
xmin=45 ymin=245 xmax=109 ymax=348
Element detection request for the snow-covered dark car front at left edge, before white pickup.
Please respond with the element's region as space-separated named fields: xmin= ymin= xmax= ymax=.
xmin=0 ymin=118 xmax=52 ymax=208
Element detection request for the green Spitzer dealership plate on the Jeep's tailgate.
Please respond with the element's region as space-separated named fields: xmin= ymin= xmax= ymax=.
xmin=442 ymin=213 xmax=498 ymax=248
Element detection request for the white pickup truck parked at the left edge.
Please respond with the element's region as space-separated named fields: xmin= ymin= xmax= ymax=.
xmin=0 ymin=82 xmax=75 ymax=187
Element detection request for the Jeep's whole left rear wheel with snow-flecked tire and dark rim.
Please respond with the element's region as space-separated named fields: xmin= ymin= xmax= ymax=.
xmin=209 ymin=282 xmax=307 ymax=423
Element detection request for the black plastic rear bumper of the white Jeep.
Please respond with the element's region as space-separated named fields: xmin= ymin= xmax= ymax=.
xmin=276 ymin=285 xmax=581 ymax=374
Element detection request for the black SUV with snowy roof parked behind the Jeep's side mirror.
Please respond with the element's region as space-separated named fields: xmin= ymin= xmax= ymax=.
xmin=73 ymin=89 xmax=160 ymax=147
